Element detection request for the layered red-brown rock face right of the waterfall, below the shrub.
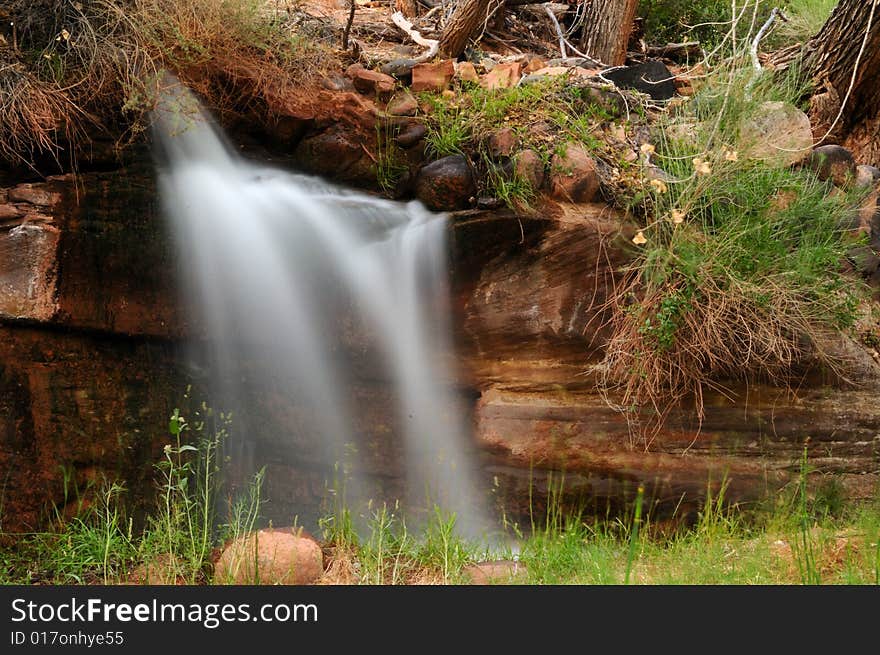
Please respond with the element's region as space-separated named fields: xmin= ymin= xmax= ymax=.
xmin=455 ymin=205 xmax=880 ymax=519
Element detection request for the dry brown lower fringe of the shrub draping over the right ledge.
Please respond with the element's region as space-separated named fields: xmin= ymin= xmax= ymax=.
xmin=600 ymin=268 xmax=843 ymax=448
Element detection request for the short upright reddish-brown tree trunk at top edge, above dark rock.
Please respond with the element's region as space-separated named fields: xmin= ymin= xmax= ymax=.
xmin=580 ymin=0 xmax=639 ymax=66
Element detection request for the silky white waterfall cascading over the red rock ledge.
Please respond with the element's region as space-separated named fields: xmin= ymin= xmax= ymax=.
xmin=155 ymin=80 xmax=488 ymax=537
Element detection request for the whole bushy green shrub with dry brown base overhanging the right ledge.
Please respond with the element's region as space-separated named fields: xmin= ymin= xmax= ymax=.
xmin=604 ymin=62 xmax=864 ymax=440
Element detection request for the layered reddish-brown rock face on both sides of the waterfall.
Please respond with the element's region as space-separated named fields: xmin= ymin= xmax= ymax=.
xmin=0 ymin=166 xmax=880 ymax=530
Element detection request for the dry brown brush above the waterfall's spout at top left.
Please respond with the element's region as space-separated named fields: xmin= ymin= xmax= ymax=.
xmin=0 ymin=0 xmax=333 ymax=169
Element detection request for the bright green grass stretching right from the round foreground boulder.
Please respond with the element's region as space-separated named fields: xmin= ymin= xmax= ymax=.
xmin=302 ymin=458 xmax=880 ymax=585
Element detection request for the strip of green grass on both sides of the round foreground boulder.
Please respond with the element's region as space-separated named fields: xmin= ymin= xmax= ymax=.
xmin=0 ymin=452 xmax=880 ymax=585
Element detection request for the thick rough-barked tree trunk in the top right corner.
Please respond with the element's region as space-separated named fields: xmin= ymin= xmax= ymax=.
xmin=806 ymin=0 xmax=880 ymax=166
